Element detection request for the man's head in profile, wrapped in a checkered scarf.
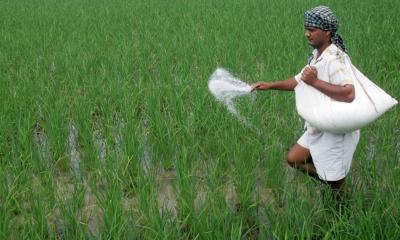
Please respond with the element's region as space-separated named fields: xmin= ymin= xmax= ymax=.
xmin=304 ymin=6 xmax=347 ymax=52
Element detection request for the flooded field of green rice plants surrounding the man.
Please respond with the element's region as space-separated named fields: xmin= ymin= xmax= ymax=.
xmin=0 ymin=0 xmax=400 ymax=239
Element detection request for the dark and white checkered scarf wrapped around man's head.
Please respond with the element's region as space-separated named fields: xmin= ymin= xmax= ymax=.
xmin=304 ymin=6 xmax=347 ymax=53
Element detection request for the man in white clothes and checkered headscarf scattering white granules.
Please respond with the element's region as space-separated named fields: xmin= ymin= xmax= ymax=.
xmin=252 ymin=6 xmax=360 ymax=197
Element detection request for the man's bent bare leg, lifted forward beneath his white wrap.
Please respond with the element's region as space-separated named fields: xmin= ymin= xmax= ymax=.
xmin=287 ymin=143 xmax=320 ymax=180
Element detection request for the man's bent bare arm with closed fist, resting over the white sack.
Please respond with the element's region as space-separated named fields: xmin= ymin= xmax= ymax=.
xmin=301 ymin=67 xmax=355 ymax=102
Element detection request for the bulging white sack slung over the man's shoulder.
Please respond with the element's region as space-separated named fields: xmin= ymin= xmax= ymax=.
xmin=295 ymin=54 xmax=397 ymax=133
